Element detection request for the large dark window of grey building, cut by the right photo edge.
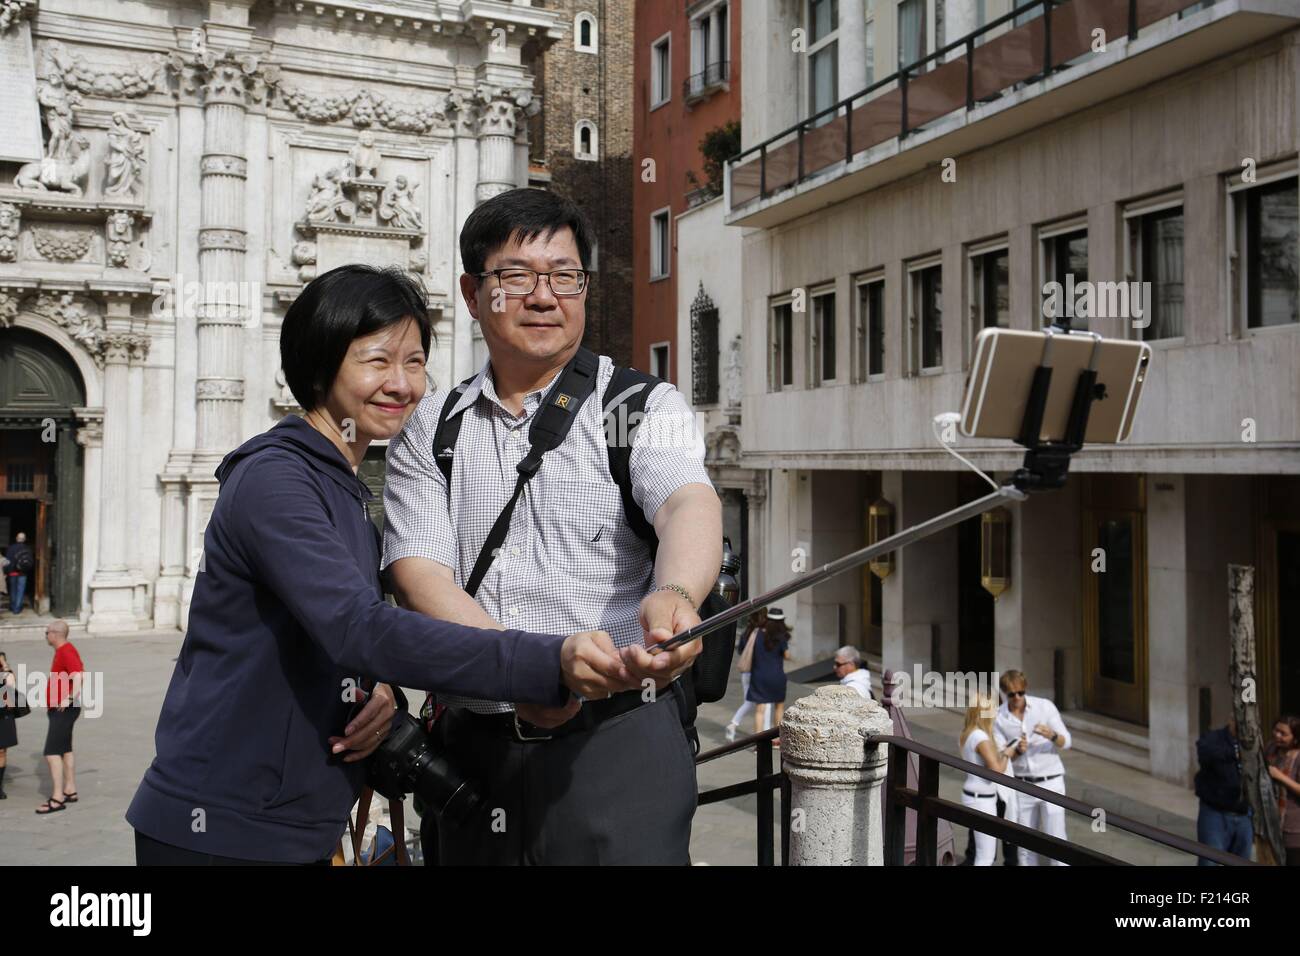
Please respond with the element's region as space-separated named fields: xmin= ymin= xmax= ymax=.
xmin=1231 ymin=172 xmax=1300 ymax=329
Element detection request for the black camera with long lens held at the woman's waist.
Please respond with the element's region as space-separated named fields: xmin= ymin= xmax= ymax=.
xmin=367 ymin=687 xmax=482 ymax=825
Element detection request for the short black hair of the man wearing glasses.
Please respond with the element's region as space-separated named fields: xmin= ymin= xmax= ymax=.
xmin=460 ymin=186 xmax=592 ymax=276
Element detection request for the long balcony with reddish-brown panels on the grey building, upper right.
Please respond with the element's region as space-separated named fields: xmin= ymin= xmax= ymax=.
xmin=727 ymin=0 xmax=1300 ymax=226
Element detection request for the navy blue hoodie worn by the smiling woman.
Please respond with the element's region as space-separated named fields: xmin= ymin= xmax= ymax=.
xmin=126 ymin=416 xmax=568 ymax=862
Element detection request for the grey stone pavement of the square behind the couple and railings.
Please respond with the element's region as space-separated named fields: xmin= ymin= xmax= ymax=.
xmin=0 ymin=631 xmax=1195 ymax=866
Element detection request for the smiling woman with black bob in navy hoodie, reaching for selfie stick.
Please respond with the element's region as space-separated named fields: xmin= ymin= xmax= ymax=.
xmin=126 ymin=265 xmax=640 ymax=865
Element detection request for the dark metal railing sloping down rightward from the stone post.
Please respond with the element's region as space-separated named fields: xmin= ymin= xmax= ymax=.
xmin=866 ymin=735 xmax=1255 ymax=866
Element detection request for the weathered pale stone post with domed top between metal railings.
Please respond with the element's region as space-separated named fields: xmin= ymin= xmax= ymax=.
xmin=781 ymin=684 xmax=893 ymax=866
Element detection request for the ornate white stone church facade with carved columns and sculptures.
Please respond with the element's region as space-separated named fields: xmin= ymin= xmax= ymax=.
xmin=0 ymin=0 xmax=571 ymax=632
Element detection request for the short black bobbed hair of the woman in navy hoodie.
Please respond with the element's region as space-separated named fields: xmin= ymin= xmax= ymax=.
xmin=280 ymin=264 xmax=433 ymax=411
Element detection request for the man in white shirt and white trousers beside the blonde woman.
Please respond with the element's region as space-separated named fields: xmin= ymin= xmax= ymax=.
xmin=993 ymin=670 xmax=1070 ymax=866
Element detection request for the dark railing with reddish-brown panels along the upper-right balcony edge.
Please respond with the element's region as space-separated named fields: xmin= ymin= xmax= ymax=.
xmin=733 ymin=0 xmax=1216 ymax=209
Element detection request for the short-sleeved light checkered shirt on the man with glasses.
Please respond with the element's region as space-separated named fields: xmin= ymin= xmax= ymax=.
xmin=382 ymin=355 xmax=712 ymax=713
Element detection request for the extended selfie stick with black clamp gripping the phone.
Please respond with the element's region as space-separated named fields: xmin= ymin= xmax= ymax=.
xmin=649 ymin=328 xmax=1101 ymax=654
